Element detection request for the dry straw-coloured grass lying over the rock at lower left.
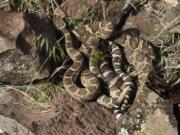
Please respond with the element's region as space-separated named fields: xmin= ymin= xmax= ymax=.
xmin=0 ymin=82 xmax=64 ymax=113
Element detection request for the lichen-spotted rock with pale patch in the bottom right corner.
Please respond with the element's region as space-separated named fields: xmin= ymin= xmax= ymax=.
xmin=117 ymin=90 xmax=178 ymax=135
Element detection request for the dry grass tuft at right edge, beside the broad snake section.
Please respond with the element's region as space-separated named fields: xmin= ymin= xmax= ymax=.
xmin=151 ymin=32 xmax=180 ymax=85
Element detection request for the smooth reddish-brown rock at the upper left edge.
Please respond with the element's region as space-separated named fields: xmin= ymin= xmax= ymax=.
xmin=0 ymin=11 xmax=25 ymax=53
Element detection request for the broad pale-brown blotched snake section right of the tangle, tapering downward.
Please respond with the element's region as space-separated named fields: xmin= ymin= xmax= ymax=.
xmin=115 ymin=34 xmax=155 ymax=94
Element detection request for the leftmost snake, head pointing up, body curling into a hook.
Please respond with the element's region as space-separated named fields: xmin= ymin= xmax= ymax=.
xmin=53 ymin=17 xmax=100 ymax=100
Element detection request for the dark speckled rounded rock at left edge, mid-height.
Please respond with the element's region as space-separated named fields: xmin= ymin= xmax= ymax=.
xmin=0 ymin=50 xmax=49 ymax=85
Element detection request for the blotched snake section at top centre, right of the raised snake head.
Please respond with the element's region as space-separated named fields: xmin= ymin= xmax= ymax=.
xmin=73 ymin=21 xmax=114 ymax=57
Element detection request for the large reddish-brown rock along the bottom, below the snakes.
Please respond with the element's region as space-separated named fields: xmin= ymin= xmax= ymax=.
xmin=0 ymin=87 xmax=116 ymax=135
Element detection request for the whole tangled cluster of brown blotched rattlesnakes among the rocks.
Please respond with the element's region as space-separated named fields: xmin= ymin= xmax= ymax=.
xmin=53 ymin=7 xmax=154 ymax=119
